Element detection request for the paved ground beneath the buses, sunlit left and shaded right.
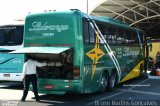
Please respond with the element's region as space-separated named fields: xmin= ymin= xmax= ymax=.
xmin=0 ymin=78 xmax=160 ymax=106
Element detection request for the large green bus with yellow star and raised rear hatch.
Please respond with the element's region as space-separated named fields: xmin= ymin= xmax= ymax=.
xmin=12 ymin=10 xmax=144 ymax=94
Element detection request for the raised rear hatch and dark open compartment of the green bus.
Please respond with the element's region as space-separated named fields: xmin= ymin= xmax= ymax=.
xmin=10 ymin=47 xmax=80 ymax=80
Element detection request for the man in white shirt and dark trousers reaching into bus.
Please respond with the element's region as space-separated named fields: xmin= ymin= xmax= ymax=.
xmin=21 ymin=59 xmax=47 ymax=102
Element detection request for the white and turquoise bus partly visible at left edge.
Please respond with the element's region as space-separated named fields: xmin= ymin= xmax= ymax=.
xmin=0 ymin=21 xmax=24 ymax=81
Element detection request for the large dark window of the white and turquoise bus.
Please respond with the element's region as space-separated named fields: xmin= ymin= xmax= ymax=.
xmin=0 ymin=26 xmax=23 ymax=46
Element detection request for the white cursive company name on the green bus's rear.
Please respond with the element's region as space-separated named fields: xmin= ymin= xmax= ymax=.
xmin=29 ymin=22 xmax=69 ymax=32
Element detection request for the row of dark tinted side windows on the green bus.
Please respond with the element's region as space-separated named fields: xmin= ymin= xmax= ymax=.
xmin=83 ymin=21 xmax=142 ymax=45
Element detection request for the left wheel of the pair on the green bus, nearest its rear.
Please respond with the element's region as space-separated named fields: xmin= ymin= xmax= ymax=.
xmin=100 ymin=73 xmax=109 ymax=93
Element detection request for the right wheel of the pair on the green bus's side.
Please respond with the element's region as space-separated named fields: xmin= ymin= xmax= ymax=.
xmin=108 ymin=72 xmax=116 ymax=91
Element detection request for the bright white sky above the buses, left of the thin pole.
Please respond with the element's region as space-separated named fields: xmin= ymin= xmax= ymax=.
xmin=0 ymin=0 xmax=87 ymax=24
